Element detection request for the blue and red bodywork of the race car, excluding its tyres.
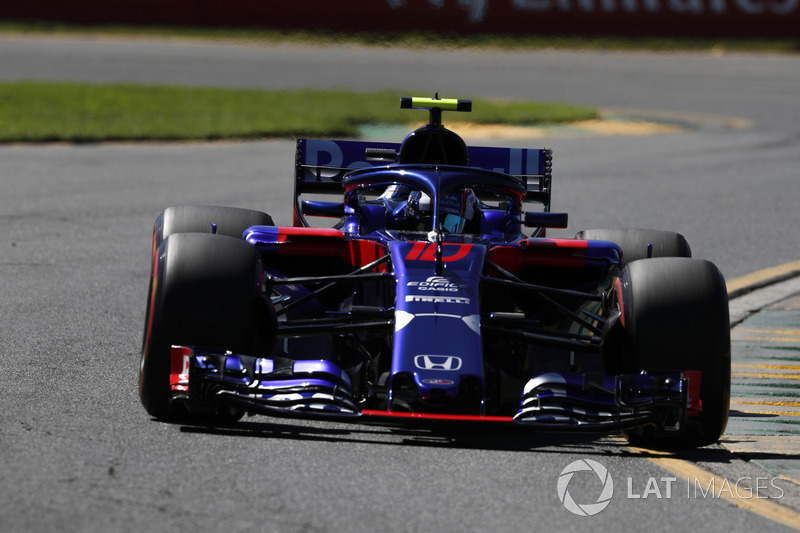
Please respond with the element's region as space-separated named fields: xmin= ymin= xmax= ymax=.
xmin=173 ymin=112 xmax=696 ymax=431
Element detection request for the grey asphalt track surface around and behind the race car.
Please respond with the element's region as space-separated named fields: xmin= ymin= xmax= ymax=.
xmin=0 ymin=37 xmax=800 ymax=532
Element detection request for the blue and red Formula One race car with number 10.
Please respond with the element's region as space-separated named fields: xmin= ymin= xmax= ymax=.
xmin=139 ymin=95 xmax=730 ymax=447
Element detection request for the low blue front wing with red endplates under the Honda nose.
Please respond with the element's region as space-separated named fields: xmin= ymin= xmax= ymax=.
xmin=170 ymin=346 xmax=701 ymax=433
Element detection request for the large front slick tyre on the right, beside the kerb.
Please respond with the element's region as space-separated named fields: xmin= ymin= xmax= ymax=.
xmin=617 ymin=257 xmax=731 ymax=448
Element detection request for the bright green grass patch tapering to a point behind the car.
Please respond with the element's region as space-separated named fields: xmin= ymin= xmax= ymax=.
xmin=0 ymin=82 xmax=597 ymax=143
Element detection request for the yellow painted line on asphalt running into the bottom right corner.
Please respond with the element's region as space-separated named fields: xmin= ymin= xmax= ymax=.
xmin=630 ymin=446 xmax=800 ymax=531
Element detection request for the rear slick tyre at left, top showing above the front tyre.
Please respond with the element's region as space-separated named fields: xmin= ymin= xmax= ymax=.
xmin=153 ymin=205 xmax=274 ymax=248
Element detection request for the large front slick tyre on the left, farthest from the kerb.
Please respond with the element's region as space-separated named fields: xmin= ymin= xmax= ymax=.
xmin=139 ymin=233 xmax=270 ymax=419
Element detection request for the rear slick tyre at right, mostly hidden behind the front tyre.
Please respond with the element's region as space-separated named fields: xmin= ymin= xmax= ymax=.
xmin=575 ymin=228 xmax=692 ymax=265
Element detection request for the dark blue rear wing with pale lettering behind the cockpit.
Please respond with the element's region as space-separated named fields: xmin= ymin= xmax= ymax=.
xmin=294 ymin=139 xmax=553 ymax=219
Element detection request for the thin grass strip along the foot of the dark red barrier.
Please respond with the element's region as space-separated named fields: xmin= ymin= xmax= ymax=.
xmin=0 ymin=21 xmax=800 ymax=53
